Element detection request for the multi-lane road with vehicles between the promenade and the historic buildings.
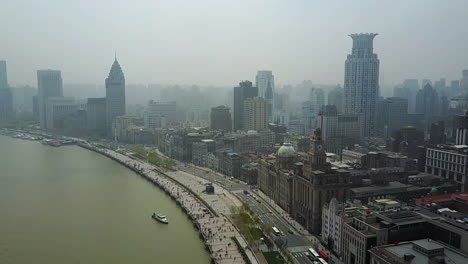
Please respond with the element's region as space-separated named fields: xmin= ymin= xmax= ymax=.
xmin=177 ymin=162 xmax=336 ymax=264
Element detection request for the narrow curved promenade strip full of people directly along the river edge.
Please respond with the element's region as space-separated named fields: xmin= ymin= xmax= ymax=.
xmin=79 ymin=143 xmax=257 ymax=264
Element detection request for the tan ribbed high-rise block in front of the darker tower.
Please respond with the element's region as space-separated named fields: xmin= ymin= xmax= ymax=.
xmin=244 ymin=96 xmax=268 ymax=130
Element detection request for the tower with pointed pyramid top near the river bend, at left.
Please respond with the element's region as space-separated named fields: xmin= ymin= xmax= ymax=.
xmin=106 ymin=58 xmax=125 ymax=135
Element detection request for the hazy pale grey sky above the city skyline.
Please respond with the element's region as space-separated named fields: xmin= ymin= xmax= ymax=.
xmin=0 ymin=0 xmax=468 ymax=86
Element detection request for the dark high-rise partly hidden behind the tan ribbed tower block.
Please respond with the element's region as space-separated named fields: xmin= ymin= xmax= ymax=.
xmin=233 ymin=81 xmax=258 ymax=131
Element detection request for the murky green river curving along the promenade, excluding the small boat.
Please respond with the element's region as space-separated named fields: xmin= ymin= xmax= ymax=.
xmin=0 ymin=135 xmax=210 ymax=264
